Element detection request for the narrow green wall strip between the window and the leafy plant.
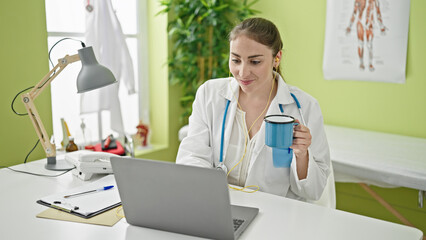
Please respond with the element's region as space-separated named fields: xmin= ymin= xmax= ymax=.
xmin=137 ymin=0 xmax=182 ymax=162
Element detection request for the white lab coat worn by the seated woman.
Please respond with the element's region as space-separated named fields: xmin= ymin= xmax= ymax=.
xmin=176 ymin=77 xmax=330 ymax=201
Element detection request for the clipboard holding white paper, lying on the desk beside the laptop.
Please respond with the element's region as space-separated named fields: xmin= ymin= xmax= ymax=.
xmin=37 ymin=175 xmax=121 ymax=219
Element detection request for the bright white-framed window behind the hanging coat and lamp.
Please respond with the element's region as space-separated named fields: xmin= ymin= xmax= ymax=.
xmin=45 ymin=0 xmax=148 ymax=146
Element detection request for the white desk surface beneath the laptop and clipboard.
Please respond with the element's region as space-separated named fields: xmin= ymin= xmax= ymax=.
xmin=0 ymin=160 xmax=423 ymax=240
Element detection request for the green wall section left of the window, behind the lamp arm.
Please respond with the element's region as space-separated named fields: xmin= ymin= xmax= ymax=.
xmin=0 ymin=0 xmax=52 ymax=166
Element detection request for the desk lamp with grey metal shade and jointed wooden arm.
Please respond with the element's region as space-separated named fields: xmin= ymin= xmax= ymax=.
xmin=22 ymin=47 xmax=117 ymax=171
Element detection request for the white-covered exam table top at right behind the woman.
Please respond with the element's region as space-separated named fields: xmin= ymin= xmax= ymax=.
xmin=325 ymin=125 xmax=426 ymax=190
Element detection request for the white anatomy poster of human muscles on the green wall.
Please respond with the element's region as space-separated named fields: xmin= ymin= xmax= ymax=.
xmin=323 ymin=0 xmax=410 ymax=83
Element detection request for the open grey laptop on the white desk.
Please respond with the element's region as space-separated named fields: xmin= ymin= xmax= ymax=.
xmin=110 ymin=157 xmax=259 ymax=239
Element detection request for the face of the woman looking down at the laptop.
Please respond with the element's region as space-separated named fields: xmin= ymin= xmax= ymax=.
xmin=229 ymin=35 xmax=274 ymax=94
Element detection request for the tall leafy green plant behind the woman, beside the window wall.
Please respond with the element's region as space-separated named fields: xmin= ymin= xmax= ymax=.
xmin=160 ymin=0 xmax=258 ymax=124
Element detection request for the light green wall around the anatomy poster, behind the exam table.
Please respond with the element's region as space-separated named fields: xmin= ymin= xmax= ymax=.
xmin=250 ymin=0 xmax=426 ymax=233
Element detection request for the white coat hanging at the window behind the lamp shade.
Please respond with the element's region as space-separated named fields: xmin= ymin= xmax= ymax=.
xmin=80 ymin=0 xmax=135 ymax=138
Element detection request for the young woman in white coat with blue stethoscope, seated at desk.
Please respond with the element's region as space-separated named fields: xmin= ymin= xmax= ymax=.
xmin=176 ymin=18 xmax=330 ymax=201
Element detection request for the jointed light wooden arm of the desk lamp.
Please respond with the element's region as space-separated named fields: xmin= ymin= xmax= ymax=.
xmin=22 ymin=54 xmax=80 ymax=158
